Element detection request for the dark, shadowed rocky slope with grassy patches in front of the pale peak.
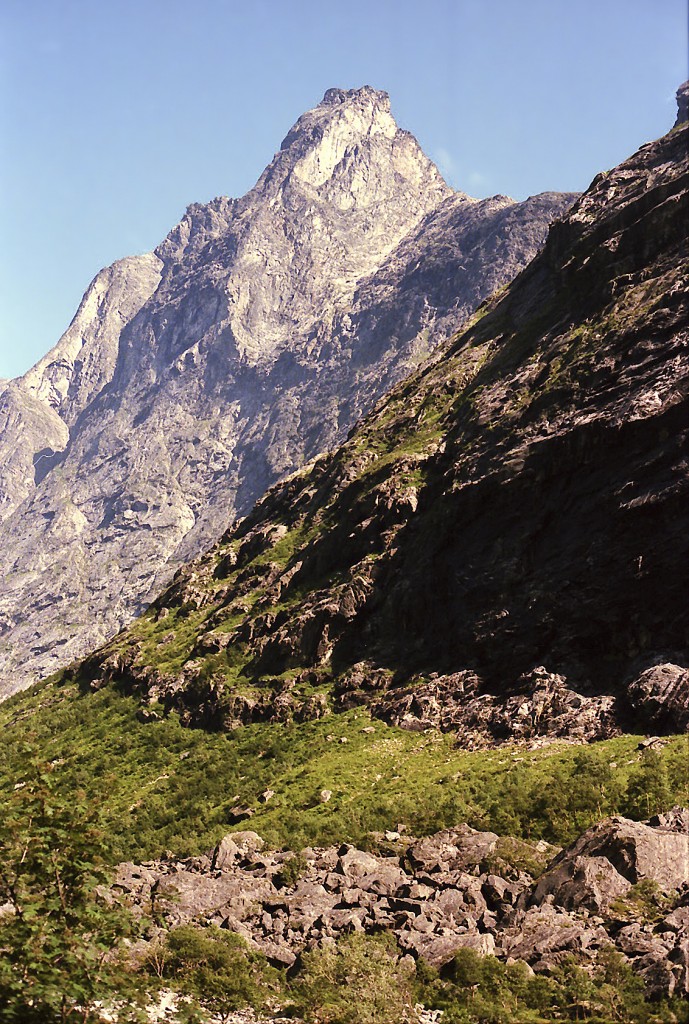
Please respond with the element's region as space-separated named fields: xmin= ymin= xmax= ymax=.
xmin=74 ymin=92 xmax=689 ymax=745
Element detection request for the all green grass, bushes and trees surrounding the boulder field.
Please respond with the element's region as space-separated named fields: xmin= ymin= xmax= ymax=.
xmin=0 ymin=684 xmax=689 ymax=1024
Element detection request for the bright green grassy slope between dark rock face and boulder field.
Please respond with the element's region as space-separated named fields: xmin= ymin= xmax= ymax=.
xmin=0 ymin=684 xmax=689 ymax=859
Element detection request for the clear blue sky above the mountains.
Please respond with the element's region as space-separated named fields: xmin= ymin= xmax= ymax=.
xmin=0 ymin=0 xmax=687 ymax=377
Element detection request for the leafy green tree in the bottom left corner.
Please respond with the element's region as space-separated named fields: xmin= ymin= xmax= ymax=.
xmin=0 ymin=765 xmax=146 ymax=1024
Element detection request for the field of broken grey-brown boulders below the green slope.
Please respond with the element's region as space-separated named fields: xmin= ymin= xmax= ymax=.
xmin=115 ymin=808 xmax=689 ymax=996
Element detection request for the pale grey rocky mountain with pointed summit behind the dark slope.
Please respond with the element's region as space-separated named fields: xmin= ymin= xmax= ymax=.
xmin=0 ymin=87 xmax=574 ymax=693
